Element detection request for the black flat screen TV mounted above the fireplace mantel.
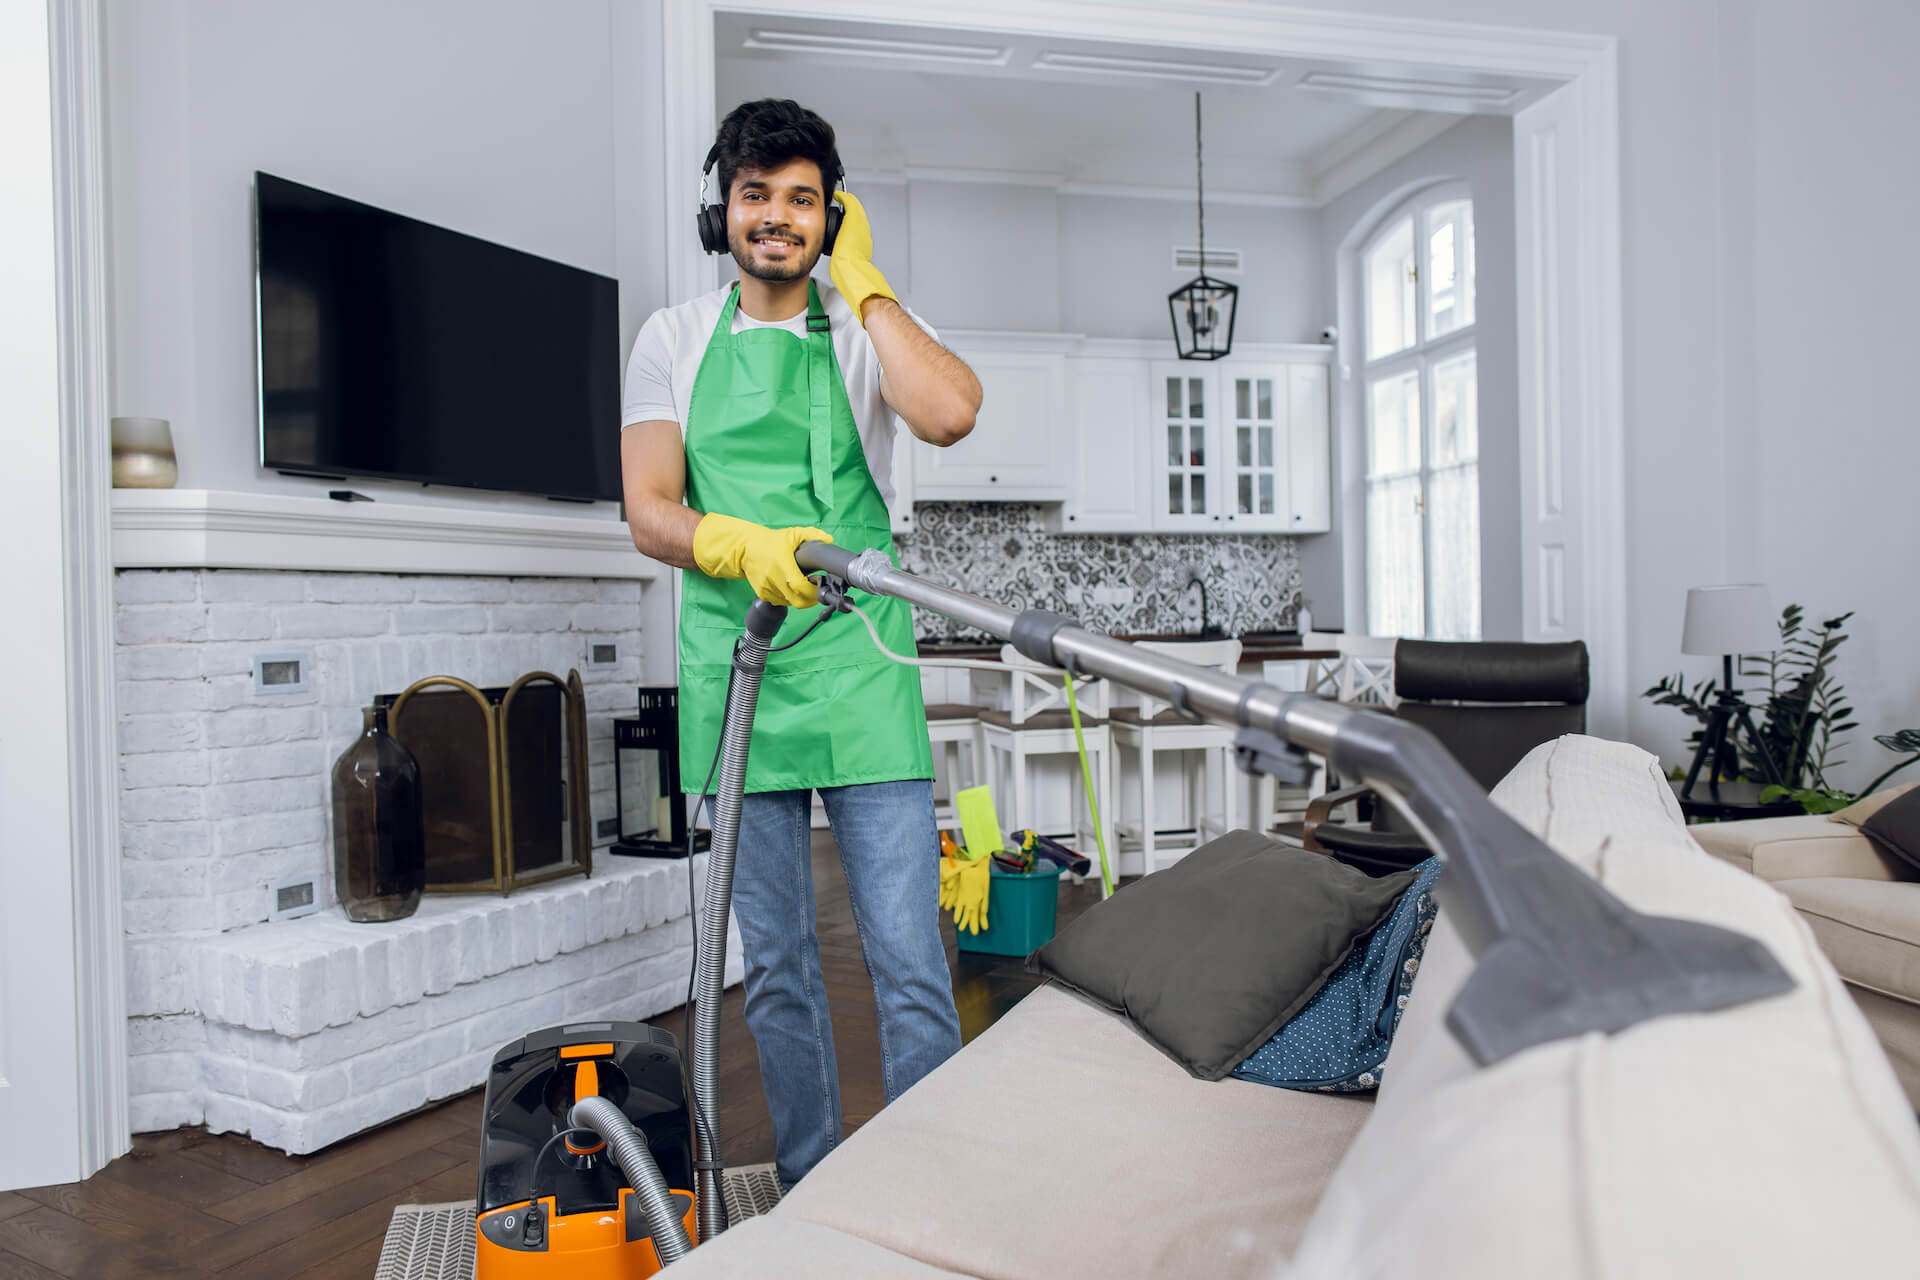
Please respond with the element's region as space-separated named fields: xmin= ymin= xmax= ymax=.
xmin=253 ymin=173 xmax=620 ymax=501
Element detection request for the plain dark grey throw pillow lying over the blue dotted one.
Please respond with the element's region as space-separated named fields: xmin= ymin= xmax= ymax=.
xmin=1027 ymin=831 xmax=1415 ymax=1080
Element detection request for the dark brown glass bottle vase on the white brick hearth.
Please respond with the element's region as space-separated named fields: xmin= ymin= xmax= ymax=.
xmin=334 ymin=706 xmax=426 ymax=923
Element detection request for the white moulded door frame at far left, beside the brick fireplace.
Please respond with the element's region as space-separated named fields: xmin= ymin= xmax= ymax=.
xmin=0 ymin=0 xmax=131 ymax=1188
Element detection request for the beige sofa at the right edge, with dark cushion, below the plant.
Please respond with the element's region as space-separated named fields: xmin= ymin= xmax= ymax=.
xmin=1692 ymin=814 xmax=1920 ymax=1109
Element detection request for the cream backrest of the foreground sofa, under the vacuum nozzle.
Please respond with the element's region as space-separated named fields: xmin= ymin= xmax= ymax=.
xmin=1294 ymin=737 xmax=1920 ymax=1280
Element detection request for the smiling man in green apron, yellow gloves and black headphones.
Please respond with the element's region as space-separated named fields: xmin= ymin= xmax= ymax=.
xmin=620 ymin=100 xmax=979 ymax=1186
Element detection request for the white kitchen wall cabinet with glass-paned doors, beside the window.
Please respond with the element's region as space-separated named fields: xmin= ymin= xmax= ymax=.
xmin=1148 ymin=359 xmax=1332 ymax=533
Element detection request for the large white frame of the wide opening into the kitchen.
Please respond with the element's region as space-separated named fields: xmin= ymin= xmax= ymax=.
xmin=660 ymin=0 xmax=1628 ymax=737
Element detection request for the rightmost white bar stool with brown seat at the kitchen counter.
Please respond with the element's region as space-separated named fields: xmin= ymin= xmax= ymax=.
xmin=1112 ymin=639 xmax=1240 ymax=875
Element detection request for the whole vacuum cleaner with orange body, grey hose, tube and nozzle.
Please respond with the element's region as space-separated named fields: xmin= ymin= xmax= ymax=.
xmin=474 ymin=543 xmax=1793 ymax=1280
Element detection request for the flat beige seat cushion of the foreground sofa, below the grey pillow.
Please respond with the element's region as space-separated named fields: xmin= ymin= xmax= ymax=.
xmin=771 ymin=986 xmax=1373 ymax=1280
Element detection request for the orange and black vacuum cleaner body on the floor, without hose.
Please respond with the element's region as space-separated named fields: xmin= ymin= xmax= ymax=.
xmin=474 ymin=1023 xmax=695 ymax=1280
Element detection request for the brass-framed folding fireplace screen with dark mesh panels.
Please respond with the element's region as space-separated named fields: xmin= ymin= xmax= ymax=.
xmin=374 ymin=672 xmax=593 ymax=894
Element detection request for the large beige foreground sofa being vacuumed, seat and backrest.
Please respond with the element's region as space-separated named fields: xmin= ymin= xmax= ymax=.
xmin=674 ymin=737 xmax=1920 ymax=1280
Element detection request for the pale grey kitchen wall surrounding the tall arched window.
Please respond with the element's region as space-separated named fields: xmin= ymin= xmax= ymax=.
xmin=1300 ymin=115 xmax=1521 ymax=639
